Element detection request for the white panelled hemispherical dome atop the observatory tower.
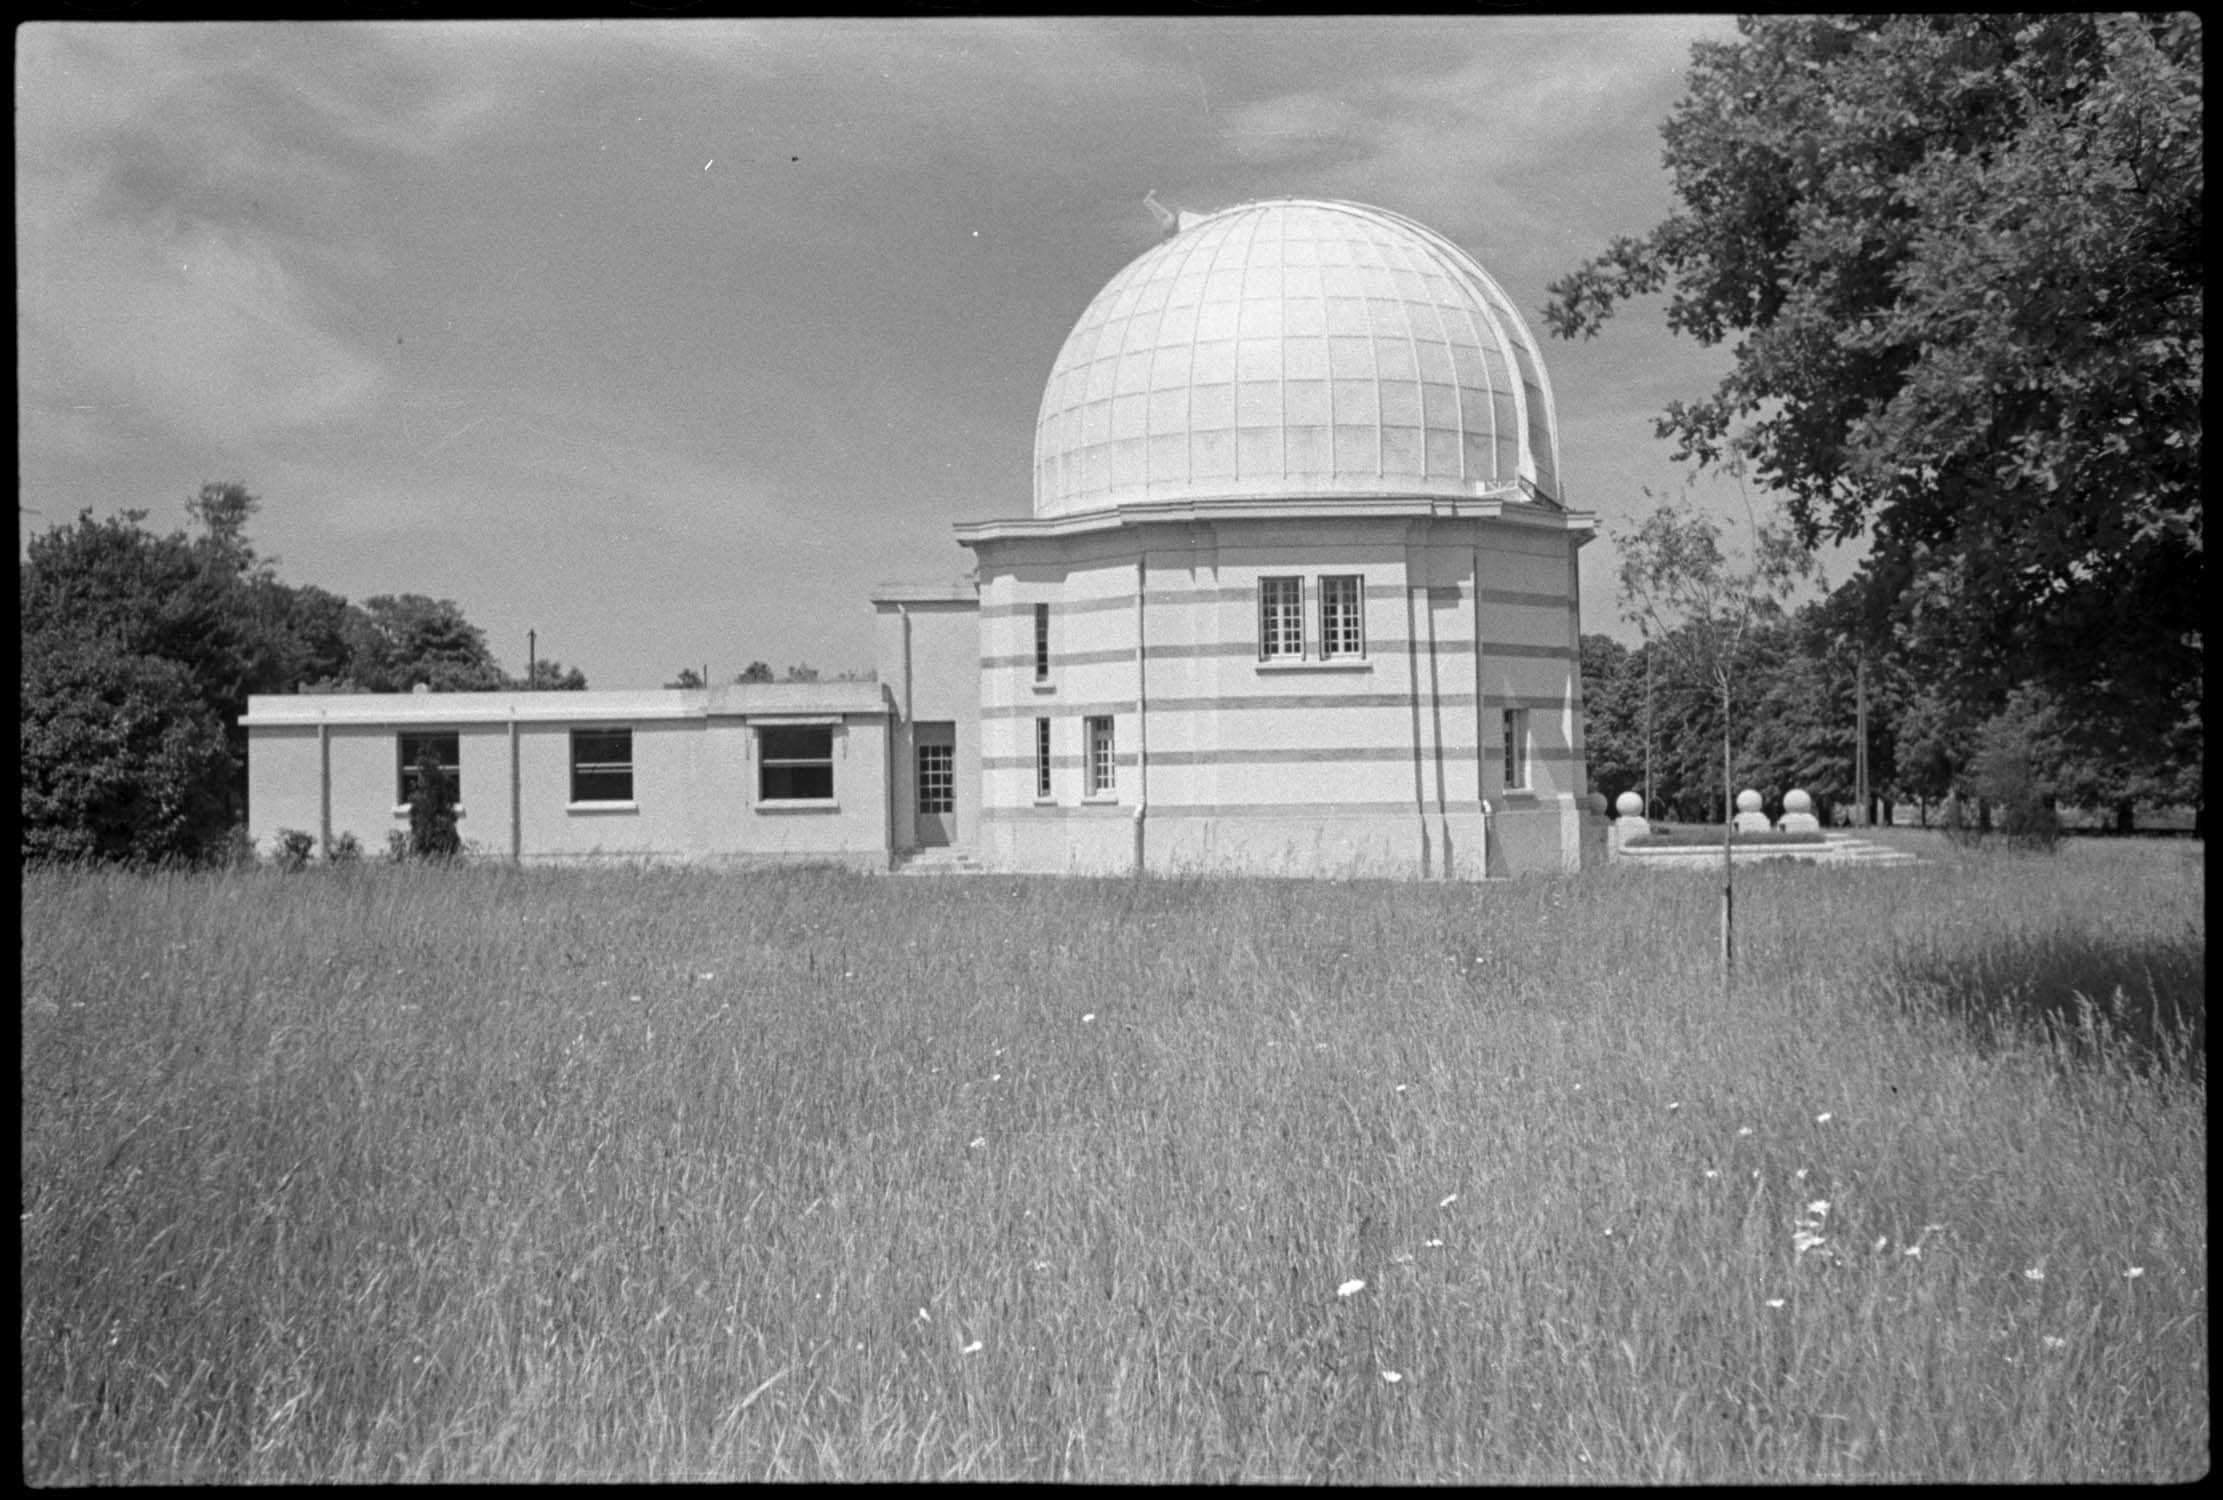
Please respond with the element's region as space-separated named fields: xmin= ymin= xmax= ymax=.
xmin=1034 ymin=198 xmax=1563 ymax=518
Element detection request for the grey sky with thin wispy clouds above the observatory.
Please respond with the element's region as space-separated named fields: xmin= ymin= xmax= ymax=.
xmin=16 ymin=16 xmax=1805 ymax=689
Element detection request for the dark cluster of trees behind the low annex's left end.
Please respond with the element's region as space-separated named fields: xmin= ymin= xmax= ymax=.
xmin=20 ymin=482 xmax=587 ymax=862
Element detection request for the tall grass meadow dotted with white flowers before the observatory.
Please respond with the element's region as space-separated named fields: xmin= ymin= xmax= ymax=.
xmin=20 ymin=840 xmax=2210 ymax=1482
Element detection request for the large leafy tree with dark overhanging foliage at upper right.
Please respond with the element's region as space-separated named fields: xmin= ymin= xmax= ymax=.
xmin=1545 ymin=13 xmax=2205 ymax=782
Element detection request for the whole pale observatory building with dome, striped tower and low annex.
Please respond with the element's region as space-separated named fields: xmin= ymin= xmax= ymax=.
xmin=245 ymin=200 xmax=1605 ymax=880
